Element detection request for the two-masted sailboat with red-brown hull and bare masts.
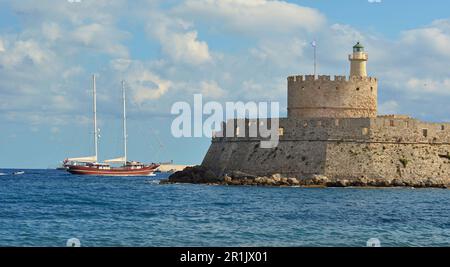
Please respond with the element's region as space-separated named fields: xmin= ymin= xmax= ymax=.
xmin=64 ymin=75 xmax=159 ymax=176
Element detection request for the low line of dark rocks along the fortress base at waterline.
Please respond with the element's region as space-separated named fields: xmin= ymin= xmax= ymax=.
xmin=161 ymin=166 xmax=450 ymax=189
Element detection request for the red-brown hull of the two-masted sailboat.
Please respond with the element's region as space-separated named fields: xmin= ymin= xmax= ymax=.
xmin=67 ymin=165 xmax=159 ymax=176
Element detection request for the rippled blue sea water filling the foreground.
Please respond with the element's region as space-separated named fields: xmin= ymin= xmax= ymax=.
xmin=0 ymin=170 xmax=450 ymax=246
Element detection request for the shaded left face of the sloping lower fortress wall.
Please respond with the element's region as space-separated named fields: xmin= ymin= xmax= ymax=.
xmin=202 ymin=139 xmax=326 ymax=177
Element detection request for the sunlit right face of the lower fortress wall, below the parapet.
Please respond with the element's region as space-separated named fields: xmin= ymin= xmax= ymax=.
xmin=324 ymin=142 xmax=450 ymax=183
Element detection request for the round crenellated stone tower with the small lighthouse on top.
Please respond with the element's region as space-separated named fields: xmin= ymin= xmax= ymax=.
xmin=288 ymin=43 xmax=378 ymax=119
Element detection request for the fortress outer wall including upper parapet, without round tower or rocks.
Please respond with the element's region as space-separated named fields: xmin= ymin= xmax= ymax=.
xmin=202 ymin=117 xmax=450 ymax=182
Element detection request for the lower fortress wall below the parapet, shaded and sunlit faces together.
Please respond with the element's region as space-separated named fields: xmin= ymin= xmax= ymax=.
xmin=202 ymin=135 xmax=450 ymax=183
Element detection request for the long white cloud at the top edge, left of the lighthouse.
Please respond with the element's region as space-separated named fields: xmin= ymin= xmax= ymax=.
xmin=176 ymin=0 xmax=325 ymax=35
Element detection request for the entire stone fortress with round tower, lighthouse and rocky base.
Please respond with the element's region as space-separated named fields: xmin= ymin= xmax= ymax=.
xmin=169 ymin=42 xmax=450 ymax=188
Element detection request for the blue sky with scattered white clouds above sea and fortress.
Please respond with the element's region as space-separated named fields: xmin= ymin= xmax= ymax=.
xmin=0 ymin=0 xmax=450 ymax=168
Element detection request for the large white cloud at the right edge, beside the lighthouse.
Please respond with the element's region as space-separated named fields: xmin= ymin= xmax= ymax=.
xmin=380 ymin=19 xmax=450 ymax=101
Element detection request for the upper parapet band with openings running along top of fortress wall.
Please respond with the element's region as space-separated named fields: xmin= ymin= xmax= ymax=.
xmin=214 ymin=116 xmax=450 ymax=144
